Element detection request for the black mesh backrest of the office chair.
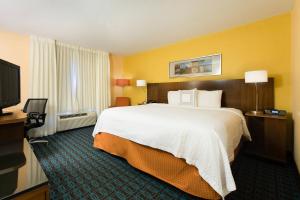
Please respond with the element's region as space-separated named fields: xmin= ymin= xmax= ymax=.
xmin=23 ymin=98 xmax=48 ymax=114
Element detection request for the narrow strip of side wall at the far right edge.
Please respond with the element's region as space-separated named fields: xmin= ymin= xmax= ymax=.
xmin=292 ymin=0 xmax=300 ymax=171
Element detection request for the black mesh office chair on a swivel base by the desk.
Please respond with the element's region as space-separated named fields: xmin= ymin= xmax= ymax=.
xmin=23 ymin=98 xmax=48 ymax=144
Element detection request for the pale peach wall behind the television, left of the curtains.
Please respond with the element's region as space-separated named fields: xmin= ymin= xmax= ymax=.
xmin=0 ymin=30 xmax=29 ymax=108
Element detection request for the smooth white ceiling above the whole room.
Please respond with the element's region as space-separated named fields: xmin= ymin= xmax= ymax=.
xmin=0 ymin=0 xmax=293 ymax=55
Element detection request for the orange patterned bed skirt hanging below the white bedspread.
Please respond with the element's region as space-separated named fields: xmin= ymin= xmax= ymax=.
xmin=94 ymin=133 xmax=221 ymax=199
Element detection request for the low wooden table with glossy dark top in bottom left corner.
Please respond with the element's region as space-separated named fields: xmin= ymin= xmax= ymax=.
xmin=0 ymin=139 xmax=49 ymax=200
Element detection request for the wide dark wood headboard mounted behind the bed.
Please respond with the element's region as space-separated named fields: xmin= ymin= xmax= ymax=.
xmin=147 ymin=78 xmax=274 ymax=112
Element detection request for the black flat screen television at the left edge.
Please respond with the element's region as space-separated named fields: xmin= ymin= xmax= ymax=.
xmin=0 ymin=59 xmax=21 ymax=116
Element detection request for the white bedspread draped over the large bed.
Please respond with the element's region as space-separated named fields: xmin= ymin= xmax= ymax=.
xmin=93 ymin=104 xmax=251 ymax=197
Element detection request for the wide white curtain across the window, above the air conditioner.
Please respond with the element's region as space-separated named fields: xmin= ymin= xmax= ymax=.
xmin=56 ymin=42 xmax=110 ymax=114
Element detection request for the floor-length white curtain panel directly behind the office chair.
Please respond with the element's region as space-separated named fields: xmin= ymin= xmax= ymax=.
xmin=29 ymin=36 xmax=57 ymax=137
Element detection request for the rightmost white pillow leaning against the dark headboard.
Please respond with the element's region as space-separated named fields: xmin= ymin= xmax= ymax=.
xmin=197 ymin=90 xmax=222 ymax=108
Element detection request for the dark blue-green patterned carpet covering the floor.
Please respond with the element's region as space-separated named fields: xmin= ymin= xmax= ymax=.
xmin=34 ymin=127 xmax=300 ymax=200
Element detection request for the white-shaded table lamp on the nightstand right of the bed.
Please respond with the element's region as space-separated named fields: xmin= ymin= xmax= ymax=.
xmin=245 ymin=70 xmax=268 ymax=115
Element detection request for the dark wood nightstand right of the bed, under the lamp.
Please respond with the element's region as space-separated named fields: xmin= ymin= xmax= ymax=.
xmin=245 ymin=113 xmax=292 ymax=162
